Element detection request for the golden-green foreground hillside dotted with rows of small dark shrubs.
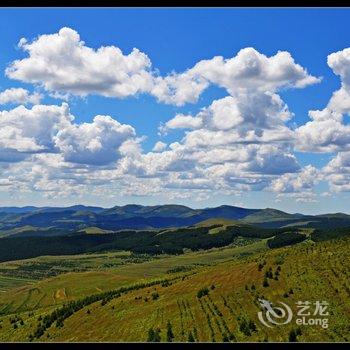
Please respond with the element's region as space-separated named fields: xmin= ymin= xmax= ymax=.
xmin=0 ymin=237 xmax=350 ymax=342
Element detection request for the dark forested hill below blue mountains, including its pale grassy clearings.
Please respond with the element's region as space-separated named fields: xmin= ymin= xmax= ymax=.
xmin=0 ymin=219 xmax=326 ymax=262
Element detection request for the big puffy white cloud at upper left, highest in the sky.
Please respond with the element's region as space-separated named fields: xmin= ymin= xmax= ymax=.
xmin=6 ymin=28 xmax=152 ymax=97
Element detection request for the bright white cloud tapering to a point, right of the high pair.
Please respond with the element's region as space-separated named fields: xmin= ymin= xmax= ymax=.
xmin=152 ymin=47 xmax=320 ymax=105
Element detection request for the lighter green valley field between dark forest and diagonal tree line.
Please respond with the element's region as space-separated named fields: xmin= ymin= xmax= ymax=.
xmin=0 ymin=240 xmax=267 ymax=313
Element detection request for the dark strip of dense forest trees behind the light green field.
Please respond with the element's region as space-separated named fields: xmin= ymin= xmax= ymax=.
xmin=0 ymin=226 xmax=266 ymax=262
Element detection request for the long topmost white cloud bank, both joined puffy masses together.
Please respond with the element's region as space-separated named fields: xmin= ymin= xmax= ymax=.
xmin=6 ymin=27 xmax=320 ymax=106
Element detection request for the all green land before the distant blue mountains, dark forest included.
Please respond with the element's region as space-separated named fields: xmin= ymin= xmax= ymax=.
xmin=0 ymin=208 xmax=350 ymax=342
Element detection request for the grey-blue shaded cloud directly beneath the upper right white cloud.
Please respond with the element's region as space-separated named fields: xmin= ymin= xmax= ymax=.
xmin=161 ymin=92 xmax=292 ymax=143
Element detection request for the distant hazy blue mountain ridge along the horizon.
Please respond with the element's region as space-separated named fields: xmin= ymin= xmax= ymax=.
xmin=0 ymin=204 xmax=350 ymax=236
